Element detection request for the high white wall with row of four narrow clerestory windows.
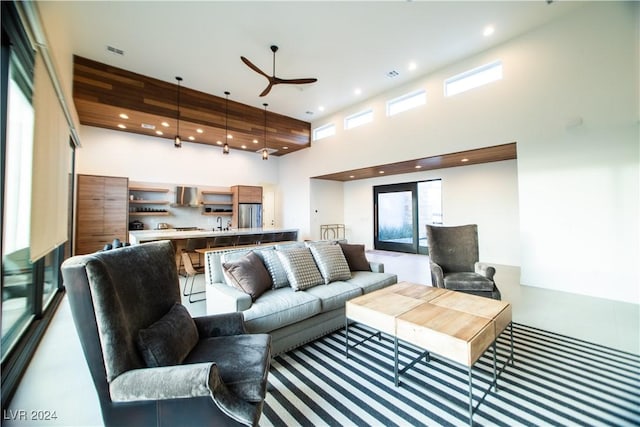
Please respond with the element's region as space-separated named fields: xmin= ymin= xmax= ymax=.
xmin=280 ymin=2 xmax=640 ymax=303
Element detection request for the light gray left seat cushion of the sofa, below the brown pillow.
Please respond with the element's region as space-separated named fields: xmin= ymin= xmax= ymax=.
xmin=242 ymin=287 xmax=322 ymax=333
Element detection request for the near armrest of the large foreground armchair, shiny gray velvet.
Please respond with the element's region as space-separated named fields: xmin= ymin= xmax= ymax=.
xmin=109 ymin=363 xmax=257 ymax=425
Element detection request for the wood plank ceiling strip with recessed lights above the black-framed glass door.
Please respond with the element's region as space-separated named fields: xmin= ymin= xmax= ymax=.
xmin=314 ymin=142 xmax=517 ymax=181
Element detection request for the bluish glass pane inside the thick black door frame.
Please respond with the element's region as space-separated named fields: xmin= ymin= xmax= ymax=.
xmin=378 ymin=191 xmax=413 ymax=243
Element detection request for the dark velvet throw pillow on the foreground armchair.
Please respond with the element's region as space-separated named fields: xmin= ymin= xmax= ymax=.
xmin=136 ymin=303 xmax=200 ymax=368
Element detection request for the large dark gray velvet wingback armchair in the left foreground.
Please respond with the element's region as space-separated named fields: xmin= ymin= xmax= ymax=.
xmin=62 ymin=241 xmax=271 ymax=426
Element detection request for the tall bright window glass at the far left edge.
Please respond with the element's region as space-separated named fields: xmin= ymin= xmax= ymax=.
xmin=2 ymin=54 xmax=34 ymax=359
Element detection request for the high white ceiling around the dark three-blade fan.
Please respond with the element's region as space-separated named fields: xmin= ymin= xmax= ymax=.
xmin=39 ymin=0 xmax=580 ymax=122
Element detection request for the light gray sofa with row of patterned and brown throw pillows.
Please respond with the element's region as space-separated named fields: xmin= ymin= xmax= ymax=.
xmin=205 ymin=241 xmax=397 ymax=356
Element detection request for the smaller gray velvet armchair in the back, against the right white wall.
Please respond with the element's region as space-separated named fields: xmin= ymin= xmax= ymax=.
xmin=427 ymin=224 xmax=501 ymax=300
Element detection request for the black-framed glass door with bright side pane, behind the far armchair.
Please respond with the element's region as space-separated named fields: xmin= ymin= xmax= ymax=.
xmin=373 ymin=179 xmax=442 ymax=254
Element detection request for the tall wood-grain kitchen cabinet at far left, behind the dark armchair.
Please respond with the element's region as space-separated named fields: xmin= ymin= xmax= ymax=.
xmin=75 ymin=175 xmax=129 ymax=254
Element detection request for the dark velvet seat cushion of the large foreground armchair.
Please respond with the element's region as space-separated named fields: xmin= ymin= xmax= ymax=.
xmin=184 ymin=334 xmax=270 ymax=402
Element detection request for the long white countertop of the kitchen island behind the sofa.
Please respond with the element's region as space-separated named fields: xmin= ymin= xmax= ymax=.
xmin=129 ymin=228 xmax=298 ymax=245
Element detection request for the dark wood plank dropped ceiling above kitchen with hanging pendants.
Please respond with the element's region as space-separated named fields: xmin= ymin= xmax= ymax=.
xmin=73 ymin=56 xmax=311 ymax=156
